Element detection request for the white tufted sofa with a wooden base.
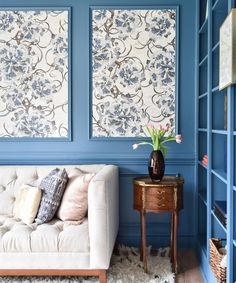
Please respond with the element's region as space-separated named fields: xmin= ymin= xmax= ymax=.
xmin=0 ymin=164 xmax=119 ymax=283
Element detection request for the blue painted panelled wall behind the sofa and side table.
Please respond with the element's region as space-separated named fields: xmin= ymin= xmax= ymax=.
xmin=0 ymin=0 xmax=196 ymax=248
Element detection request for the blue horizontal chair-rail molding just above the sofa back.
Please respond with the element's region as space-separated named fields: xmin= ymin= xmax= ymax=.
xmin=0 ymin=151 xmax=196 ymax=166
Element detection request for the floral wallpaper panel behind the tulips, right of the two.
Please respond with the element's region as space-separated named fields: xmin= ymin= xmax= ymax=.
xmin=92 ymin=9 xmax=176 ymax=137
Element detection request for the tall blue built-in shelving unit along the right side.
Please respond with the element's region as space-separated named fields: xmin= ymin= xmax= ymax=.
xmin=196 ymin=0 xmax=236 ymax=283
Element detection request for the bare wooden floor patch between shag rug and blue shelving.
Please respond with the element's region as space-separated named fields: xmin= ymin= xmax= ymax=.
xmin=176 ymin=250 xmax=204 ymax=283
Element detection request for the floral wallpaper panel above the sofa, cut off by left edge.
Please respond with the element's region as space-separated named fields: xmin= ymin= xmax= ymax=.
xmin=0 ymin=10 xmax=68 ymax=138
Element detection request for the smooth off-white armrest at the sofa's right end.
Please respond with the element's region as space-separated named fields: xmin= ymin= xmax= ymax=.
xmin=88 ymin=165 xmax=119 ymax=269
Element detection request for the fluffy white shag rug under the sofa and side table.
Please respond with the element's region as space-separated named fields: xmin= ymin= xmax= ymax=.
xmin=0 ymin=246 xmax=175 ymax=283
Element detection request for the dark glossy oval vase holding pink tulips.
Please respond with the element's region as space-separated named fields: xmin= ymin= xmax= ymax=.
xmin=148 ymin=150 xmax=165 ymax=182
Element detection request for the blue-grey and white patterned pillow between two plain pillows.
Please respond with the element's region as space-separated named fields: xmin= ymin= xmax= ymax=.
xmin=35 ymin=168 xmax=68 ymax=224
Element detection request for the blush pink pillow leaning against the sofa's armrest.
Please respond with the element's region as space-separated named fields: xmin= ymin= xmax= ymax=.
xmin=57 ymin=168 xmax=94 ymax=224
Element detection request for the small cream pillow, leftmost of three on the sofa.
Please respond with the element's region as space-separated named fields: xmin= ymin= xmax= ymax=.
xmin=14 ymin=185 xmax=42 ymax=224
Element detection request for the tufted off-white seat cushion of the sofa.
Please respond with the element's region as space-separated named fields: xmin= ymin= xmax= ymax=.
xmin=0 ymin=215 xmax=89 ymax=253
